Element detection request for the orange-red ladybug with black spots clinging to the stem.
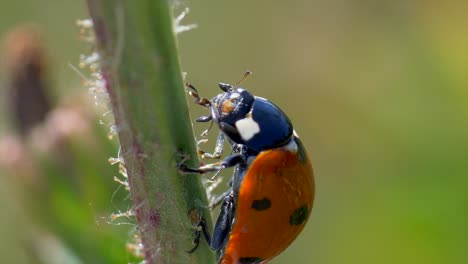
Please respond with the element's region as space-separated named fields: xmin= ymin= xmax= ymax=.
xmin=179 ymin=72 xmax=315 ymax=264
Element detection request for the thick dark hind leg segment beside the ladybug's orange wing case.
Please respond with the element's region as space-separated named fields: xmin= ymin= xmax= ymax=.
xmin=210 ymin=192 xmax=234 ymax=250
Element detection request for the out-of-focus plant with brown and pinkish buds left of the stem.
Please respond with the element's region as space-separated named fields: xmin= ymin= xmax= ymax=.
xmin=0 ymin=26 xmax=136 ymax=263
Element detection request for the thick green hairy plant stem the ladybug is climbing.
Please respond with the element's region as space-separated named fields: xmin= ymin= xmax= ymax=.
xmin=88 ymin=0 xmax=214 ymax=263
